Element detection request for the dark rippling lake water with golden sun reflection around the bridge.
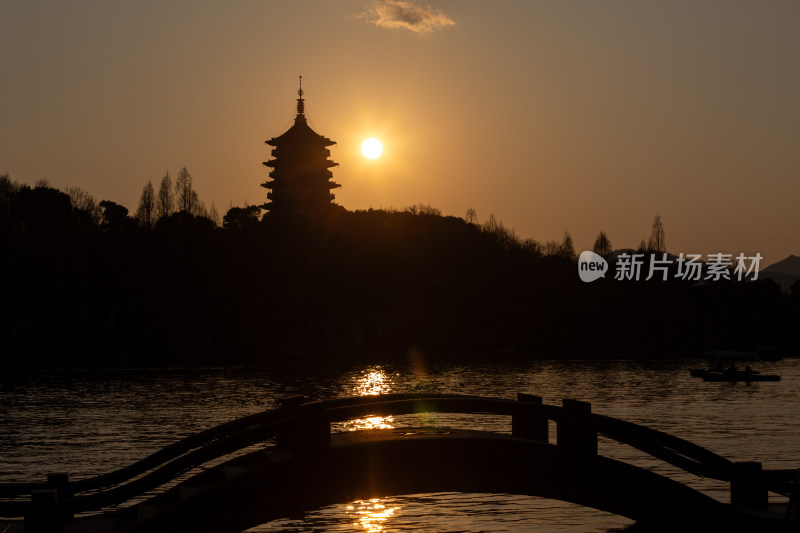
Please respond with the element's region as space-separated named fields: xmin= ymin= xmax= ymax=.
xmin=0 ymin=355 xmax=800 ymax=532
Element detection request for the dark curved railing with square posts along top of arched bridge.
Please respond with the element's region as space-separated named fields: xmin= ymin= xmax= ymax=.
xmin=0 ymin=394 xmax=798 ymax=517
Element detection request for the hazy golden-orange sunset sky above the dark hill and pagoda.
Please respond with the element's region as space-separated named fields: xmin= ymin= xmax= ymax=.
xmin=0 ymin=0 xmax=800 ymax=266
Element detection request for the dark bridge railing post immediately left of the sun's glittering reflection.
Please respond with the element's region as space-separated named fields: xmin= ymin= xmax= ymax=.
xmin=275 ymin=396 xmax=331 ymax=455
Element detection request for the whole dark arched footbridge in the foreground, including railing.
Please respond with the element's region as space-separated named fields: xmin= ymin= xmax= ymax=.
xmin=0 ymin=394 xmax=800 ymax=533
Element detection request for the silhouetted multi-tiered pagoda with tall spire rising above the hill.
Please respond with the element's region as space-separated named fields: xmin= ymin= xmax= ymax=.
xmin=261 ymin=76 xmax=341 ymax=216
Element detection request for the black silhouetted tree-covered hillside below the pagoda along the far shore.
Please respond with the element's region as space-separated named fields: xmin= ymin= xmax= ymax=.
xmin=0 ymin=175 xmax=800 ymax=366
